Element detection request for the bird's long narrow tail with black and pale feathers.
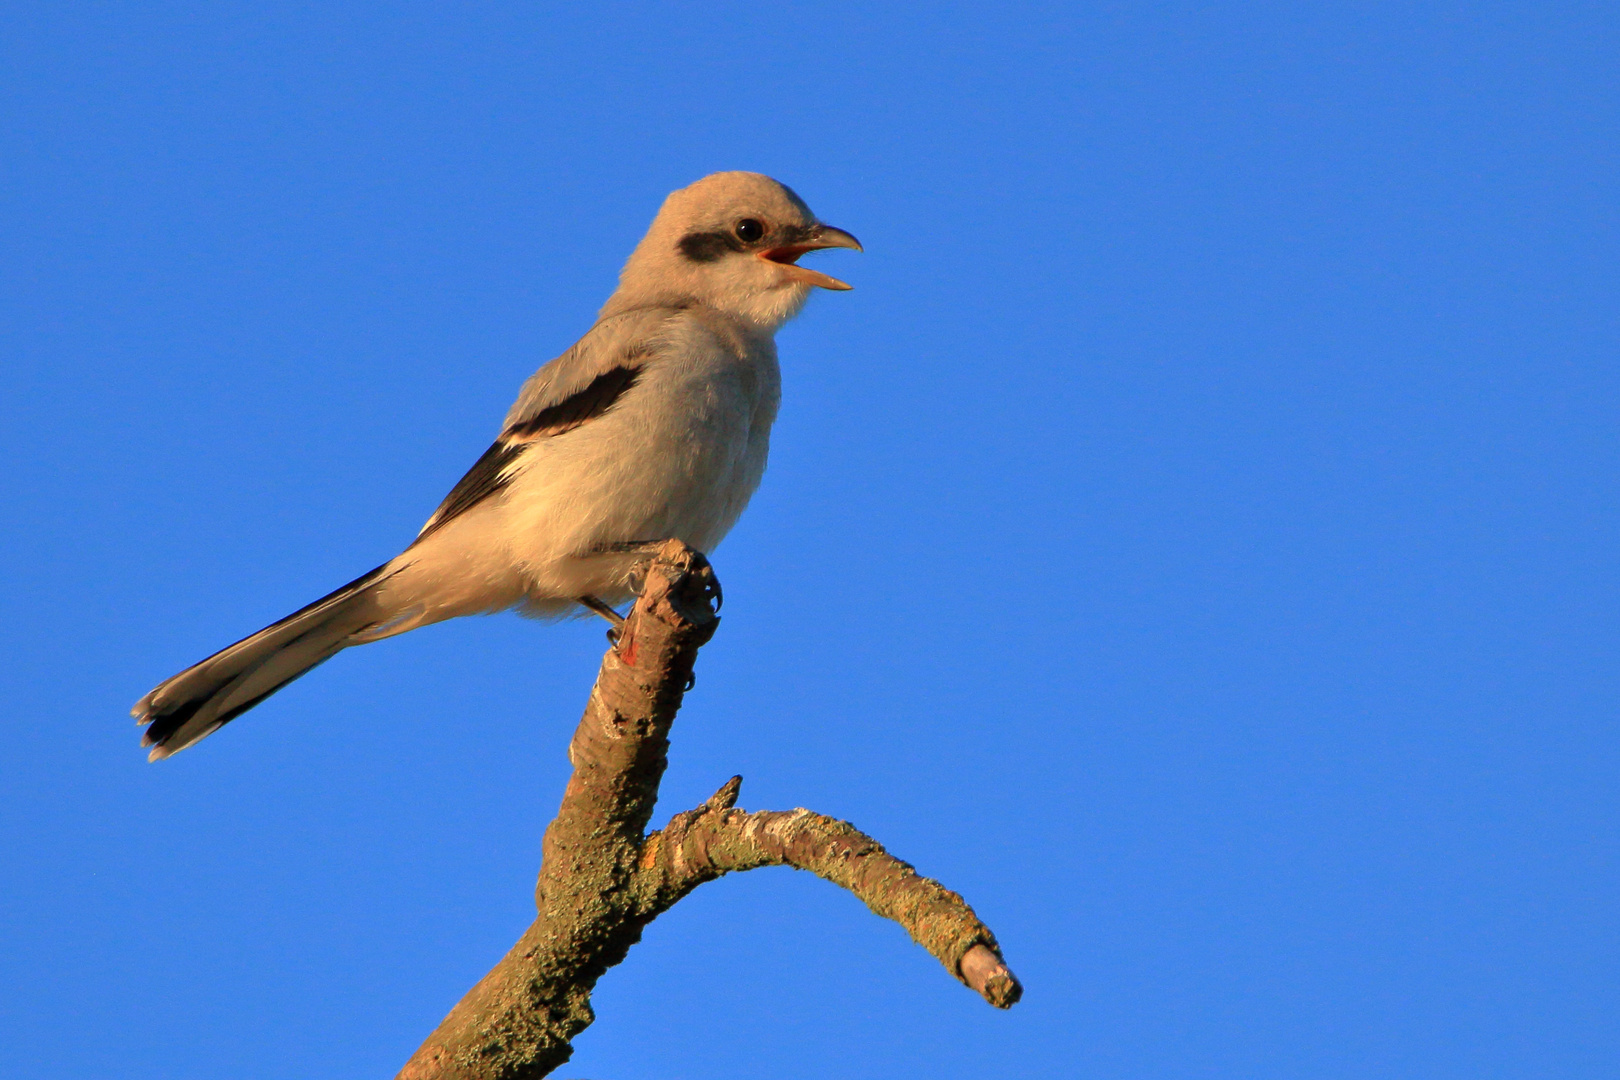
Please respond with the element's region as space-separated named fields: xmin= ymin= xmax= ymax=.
xmin=131 ymin=563 xmax=407 ymax=761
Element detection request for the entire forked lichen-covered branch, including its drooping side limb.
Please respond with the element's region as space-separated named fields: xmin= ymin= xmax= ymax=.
xmin=399 ymin=541 xmax=1021 ymax=1080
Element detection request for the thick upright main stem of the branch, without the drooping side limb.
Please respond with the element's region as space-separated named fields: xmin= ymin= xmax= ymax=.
xmin=399 ymin=541 xmax=719 ymax=1080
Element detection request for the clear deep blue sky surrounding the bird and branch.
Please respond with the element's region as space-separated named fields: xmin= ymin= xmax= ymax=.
xmin=0 ymin=3 xmax=1620 ymax=1080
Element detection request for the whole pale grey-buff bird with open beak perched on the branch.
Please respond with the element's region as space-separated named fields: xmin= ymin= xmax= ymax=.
xmin=133 ymin=172 xmax=860 ymax=761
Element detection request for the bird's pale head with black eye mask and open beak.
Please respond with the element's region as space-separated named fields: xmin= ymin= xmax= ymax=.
xmin=604 ymin=172 xmax=860 ymax=332
